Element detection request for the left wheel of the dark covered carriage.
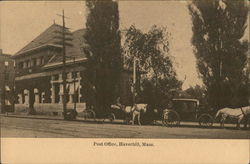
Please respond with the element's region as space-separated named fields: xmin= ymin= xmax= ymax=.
xmin=162 ymin=110 xmax=180 ymax=126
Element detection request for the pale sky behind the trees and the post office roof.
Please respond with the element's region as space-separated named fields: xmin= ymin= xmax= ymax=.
xmin=0 ymin=0 xmax=249 ymax=89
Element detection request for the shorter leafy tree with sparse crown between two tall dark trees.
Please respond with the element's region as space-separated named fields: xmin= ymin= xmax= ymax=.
xmin=124 ymin=25 xmax=182 ymax=107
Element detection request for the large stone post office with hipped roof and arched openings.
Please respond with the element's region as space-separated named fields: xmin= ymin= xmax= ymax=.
xmin=13 ymin=24 xmax=135 ymax=114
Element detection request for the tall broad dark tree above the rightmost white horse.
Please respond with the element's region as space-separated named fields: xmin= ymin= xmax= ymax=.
xmin=188 ymin=0 xmax=248 ymax=109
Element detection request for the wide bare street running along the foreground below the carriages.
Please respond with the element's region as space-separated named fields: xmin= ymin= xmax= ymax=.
xmin=0 ymin=116 xmax=250 ymax=139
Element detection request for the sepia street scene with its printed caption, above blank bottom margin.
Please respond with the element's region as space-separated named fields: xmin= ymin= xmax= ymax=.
xmin=0 ymin=0 xmax=250 ymax=163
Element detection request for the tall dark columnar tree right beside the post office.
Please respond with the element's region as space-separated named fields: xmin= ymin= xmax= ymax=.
xmin=84 ymin=0 xmax=122 ymax=116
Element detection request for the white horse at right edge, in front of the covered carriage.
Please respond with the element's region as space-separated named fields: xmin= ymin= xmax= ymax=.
xmin=215 ymin=106 xmax=250 ymax=129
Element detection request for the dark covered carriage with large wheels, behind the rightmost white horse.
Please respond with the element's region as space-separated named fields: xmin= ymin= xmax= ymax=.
xmin=162 ymin=98 xmax=214 ymax=127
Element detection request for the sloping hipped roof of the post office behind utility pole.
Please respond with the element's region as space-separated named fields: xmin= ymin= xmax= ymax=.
xmin=14 ymin=24 xmax=86 ymax=67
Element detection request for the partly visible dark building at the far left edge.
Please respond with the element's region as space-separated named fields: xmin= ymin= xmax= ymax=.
xmin=0 ymin=49 xmax=14 ymax=113
